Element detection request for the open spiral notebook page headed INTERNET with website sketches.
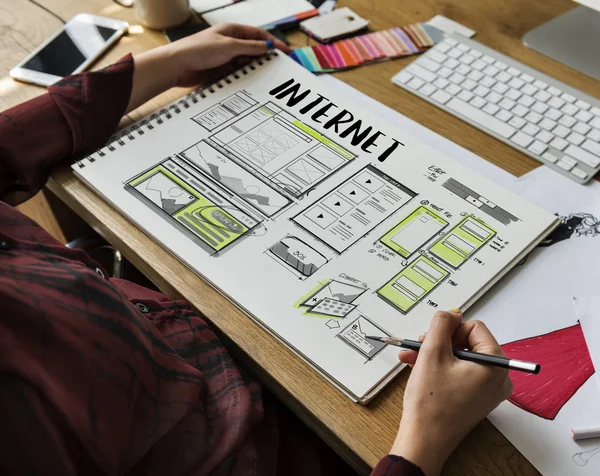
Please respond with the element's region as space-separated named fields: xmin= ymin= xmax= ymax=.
xmin=73 ymin=52 xmax=558 ymax=403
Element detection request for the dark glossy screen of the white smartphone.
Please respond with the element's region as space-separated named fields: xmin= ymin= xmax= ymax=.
xmin=22 ymin=20 xmax=117 ymax=77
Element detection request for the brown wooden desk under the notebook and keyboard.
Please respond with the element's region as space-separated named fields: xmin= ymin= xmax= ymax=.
xmin=0 ymin=0 xmax=600 ymax=476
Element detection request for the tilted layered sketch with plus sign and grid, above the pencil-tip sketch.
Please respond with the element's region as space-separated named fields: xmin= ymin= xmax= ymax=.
xmin=294 ymin=280 xmax=367 ymax=318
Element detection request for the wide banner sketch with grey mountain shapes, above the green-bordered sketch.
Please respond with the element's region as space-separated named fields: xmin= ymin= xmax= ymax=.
xmin=180 ymin=141 xmax=292 ymax=217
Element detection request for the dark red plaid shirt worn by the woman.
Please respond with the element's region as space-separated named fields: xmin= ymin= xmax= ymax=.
xmin=0 ymin=56 xmax=422 ymax=476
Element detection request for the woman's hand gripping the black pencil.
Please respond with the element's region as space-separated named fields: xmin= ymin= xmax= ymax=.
xmin=390 ymin=312 xmax=513 ymax=476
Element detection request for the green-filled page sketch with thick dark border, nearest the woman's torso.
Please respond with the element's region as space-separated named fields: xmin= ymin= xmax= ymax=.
xmin=125 ymin=158 xmax=260 ymax=254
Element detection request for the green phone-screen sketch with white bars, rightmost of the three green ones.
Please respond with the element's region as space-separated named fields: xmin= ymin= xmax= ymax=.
xmin=429 ymin=215 xmax=496 ymax=268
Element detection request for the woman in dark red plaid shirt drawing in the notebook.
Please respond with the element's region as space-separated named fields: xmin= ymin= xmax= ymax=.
xmin=0 ymin=25 xmax=511 ymax=475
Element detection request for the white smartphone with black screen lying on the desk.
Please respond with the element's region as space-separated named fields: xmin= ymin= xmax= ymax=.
xmin=10 ymin=13 xmax=129 ymax=86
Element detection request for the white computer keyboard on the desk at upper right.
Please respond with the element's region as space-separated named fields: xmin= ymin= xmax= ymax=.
xmin=392 ymin=35 xmax=600 ymax=183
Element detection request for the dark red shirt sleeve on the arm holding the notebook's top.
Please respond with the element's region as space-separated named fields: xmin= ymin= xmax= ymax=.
xmin=0 ymin=55 xmax=133 ymax=205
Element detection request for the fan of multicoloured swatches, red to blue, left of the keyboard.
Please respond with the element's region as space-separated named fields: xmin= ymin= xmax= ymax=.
xmin=291 ymin=23 xmax=443 ymax=73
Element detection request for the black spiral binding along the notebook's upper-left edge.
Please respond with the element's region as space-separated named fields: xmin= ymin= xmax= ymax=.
xmin=75 ymin=51 xmax=277 ymax=169
